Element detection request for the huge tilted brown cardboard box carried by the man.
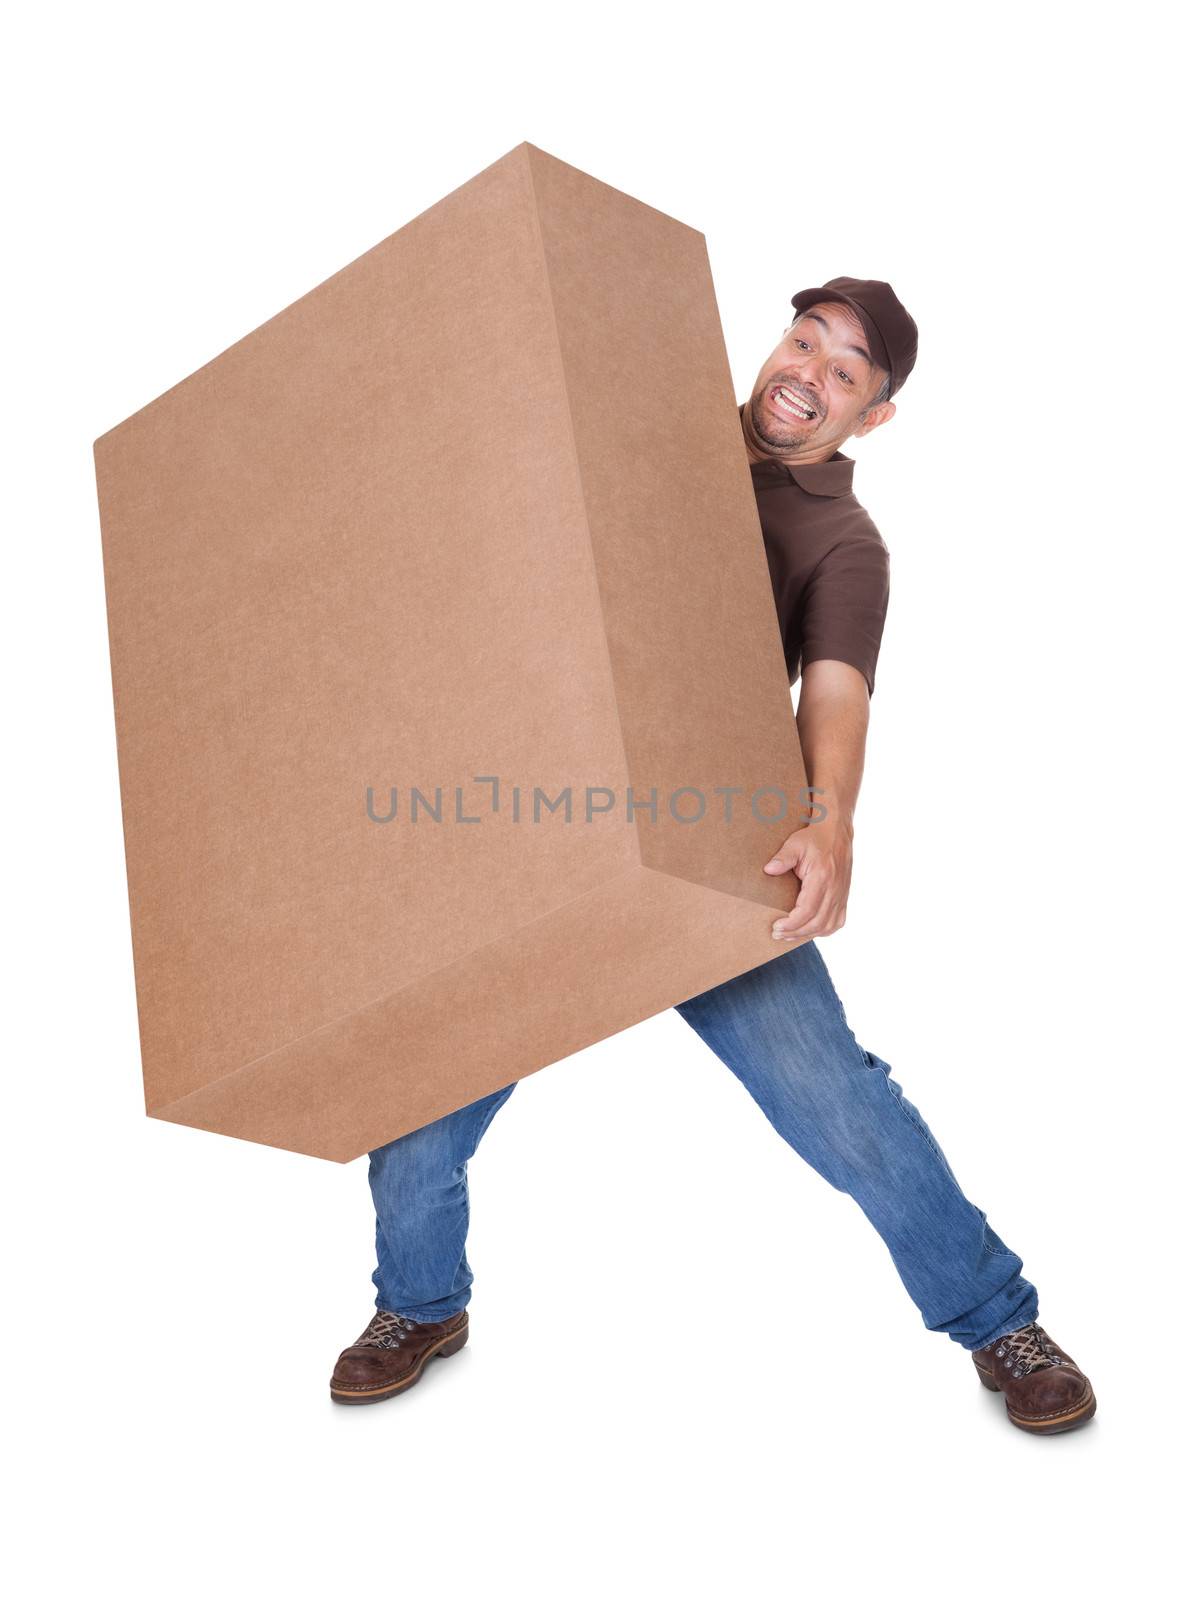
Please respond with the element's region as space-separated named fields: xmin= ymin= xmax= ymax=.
xmin=94 ymin=144 xmax=804 ymax=1162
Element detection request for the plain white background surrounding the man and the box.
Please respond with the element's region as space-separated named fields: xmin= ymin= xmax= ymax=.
xmin=0 ymin=3 xmax=1182 ymax=1600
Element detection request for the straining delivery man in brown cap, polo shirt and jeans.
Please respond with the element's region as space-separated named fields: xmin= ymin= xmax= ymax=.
xmin=329 ymin=278 xmax=1095 ymax=1434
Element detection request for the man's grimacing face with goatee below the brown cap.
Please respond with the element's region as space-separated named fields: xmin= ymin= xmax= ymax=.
xmin=744 ymin=301 xmax=897 ymax=466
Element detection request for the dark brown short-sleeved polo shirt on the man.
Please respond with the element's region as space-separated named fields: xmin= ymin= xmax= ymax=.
xmin=737 ymin=405 xmax=889 ymax=694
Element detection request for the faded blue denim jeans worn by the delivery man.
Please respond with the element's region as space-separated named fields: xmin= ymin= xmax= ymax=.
xmin=369 ymin=941 xmax=1036 ymax=1350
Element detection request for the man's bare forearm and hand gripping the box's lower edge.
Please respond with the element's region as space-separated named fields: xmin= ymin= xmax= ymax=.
xmin=766 ymin=661 xmax=868 ymax=944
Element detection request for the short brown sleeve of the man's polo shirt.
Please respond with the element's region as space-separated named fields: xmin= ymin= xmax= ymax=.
xmin=803 ymin=530 xmax=889 ymax=694
